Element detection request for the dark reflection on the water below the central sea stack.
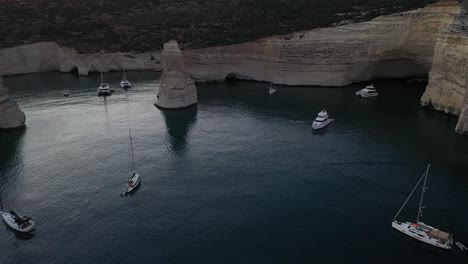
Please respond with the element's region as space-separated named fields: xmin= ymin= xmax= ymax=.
xmin=162 ymin=107 xmax=198 ymax=155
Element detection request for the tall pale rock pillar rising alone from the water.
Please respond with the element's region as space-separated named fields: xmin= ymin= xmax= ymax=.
xmin=155 ymin=40 xmax=198 ymax=110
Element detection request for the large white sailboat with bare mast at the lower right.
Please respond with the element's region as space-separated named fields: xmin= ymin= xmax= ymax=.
xmin=392 ymin=165 xmax=453 ymax=249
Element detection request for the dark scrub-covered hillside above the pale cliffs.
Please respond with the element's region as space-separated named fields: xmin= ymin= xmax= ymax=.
xmin=0 ymin=0 xmax=435 ymax=52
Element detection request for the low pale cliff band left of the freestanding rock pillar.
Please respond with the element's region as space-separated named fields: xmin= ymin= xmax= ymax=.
xmin=0 ymin=42 xmax=161 ymax=75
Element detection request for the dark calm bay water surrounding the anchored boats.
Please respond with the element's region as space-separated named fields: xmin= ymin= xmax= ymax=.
xmin=0 ymin=72 xmax=468 ymax=263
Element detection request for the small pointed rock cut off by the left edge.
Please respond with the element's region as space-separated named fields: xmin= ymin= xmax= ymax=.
xmin=0 ymin=77 xmax=26 ymax=130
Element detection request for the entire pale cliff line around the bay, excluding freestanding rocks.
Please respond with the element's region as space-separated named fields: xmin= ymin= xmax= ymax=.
xmin=0 ymin=1 xmax=468 ymax=134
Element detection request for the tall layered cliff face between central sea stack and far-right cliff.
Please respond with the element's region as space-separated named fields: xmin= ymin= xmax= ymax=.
xmin=184 ymin=2 xmax=461 ymax=86
